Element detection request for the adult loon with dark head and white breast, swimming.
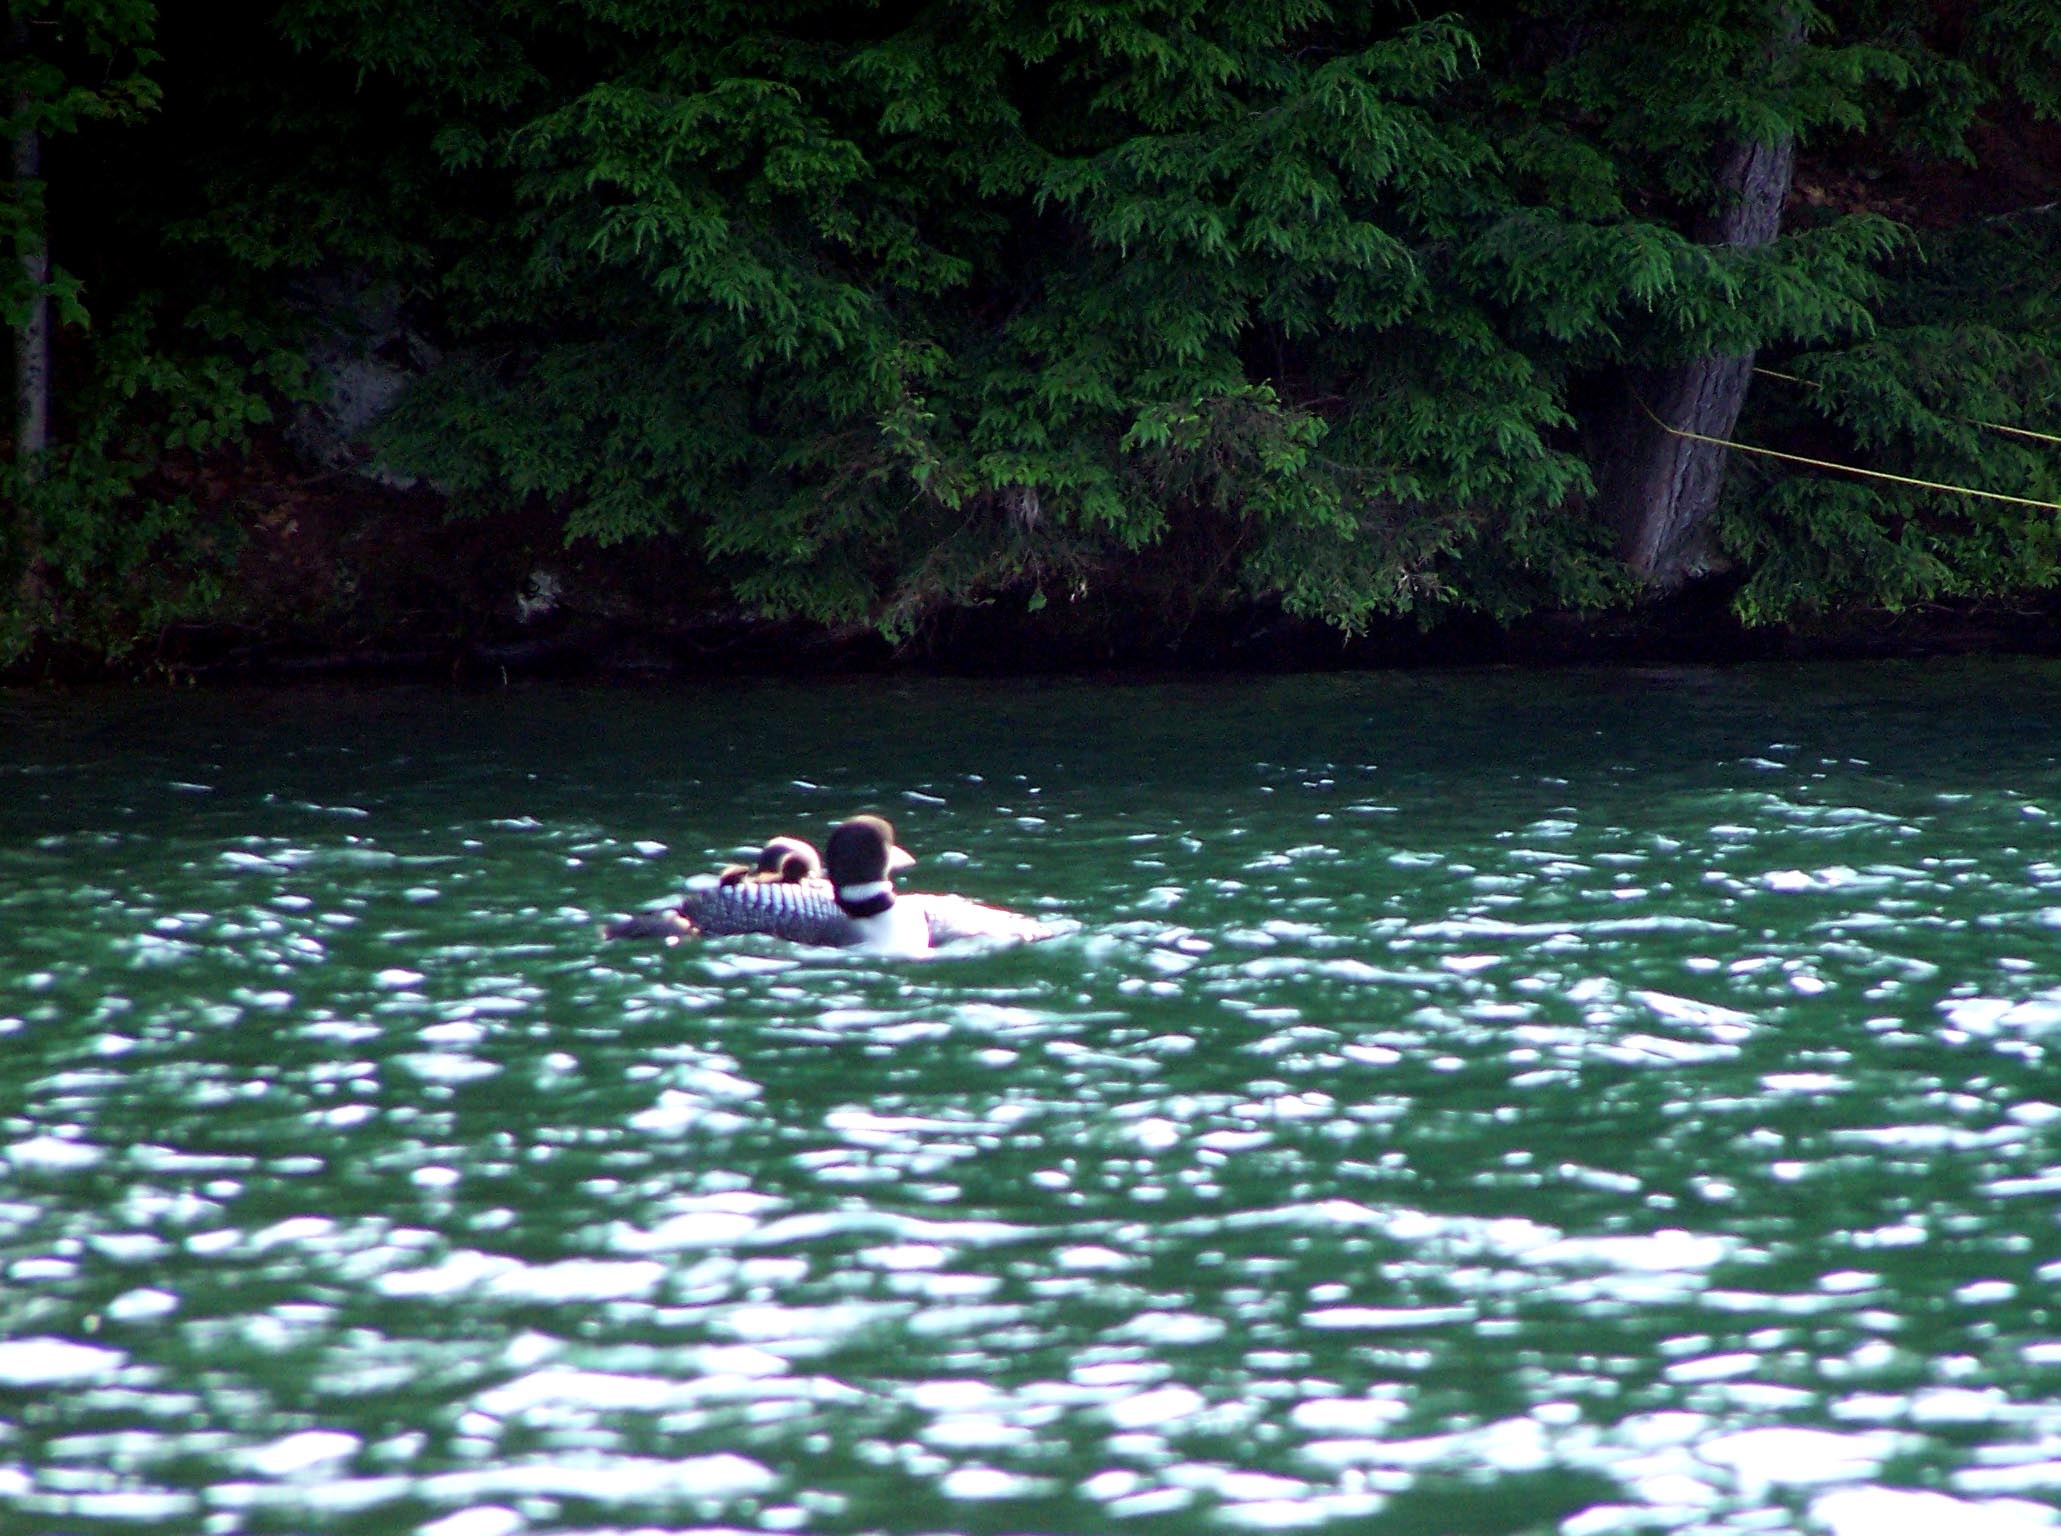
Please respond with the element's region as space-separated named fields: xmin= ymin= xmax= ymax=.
xmin=606 ymin=816 xmax=1057 ymax=955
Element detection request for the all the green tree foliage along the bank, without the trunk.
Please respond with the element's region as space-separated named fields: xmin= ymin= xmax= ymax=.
xmin=10 ymin=0 xmax=2057 ymax=659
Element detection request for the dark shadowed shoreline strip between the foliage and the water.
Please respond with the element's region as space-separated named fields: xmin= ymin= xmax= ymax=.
xmin=0 ymin=581 xmax=2061 ymax=687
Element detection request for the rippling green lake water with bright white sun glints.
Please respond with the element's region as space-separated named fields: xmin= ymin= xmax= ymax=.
xmin=0 ymin=664 xmax=2061 ymax=1536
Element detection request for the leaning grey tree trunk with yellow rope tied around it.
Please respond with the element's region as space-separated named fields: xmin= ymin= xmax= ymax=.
xmin=1601 ymin=115 xmax=1795 ymax=588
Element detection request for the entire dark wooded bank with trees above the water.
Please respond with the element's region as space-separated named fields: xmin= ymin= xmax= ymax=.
xmin=0 ymin=0 xmax=2061 ymax=674
